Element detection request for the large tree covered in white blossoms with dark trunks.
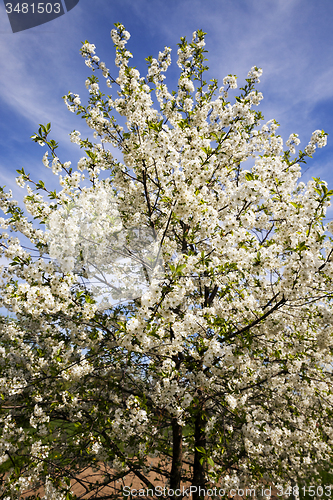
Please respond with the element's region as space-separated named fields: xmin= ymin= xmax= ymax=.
xmin=0 ymin=24 xmax=333 ymax=499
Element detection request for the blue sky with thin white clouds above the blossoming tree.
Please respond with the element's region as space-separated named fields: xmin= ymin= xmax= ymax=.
xmin=0 ymin=0 xmax=333 ymax=213
